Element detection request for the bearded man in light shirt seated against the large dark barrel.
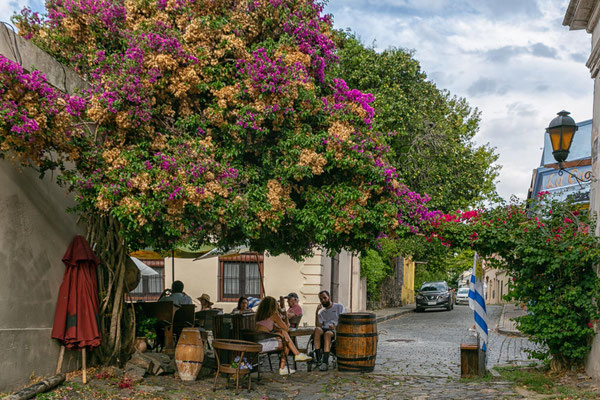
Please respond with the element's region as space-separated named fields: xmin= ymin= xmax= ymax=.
xmin=313 ymin=290 xmax=346 ymax=371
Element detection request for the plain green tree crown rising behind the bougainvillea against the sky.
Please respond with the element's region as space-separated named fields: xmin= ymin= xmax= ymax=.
xmin=335 ymin=32 xmax=499 ymax=212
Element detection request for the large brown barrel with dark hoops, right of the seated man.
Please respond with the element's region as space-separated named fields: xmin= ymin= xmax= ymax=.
xmin=336 ymin=313 xmax=377 ymax=372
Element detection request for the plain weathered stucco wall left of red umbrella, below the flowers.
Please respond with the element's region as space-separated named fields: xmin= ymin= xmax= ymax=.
xmin=0 ymin=160 xmax=82 ymax=392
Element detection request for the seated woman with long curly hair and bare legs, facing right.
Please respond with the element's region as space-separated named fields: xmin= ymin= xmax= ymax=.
xmin=256 ymin=296 xmax=312 ymax=375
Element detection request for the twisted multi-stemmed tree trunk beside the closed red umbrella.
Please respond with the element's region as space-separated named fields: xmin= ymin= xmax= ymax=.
xmin=87 ymin=215 xmax=135 ymax=366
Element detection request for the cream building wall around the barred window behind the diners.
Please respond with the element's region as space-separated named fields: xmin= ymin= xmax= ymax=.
xmin=165 ymin=251 xmax=366 ymax=326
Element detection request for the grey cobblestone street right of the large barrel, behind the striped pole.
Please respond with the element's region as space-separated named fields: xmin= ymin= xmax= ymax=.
xmin=376 ymin=306 xmax=535 ymax=377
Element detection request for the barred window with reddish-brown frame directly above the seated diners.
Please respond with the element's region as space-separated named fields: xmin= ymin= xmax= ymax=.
xmin=219 ymin=253 xmax=264 ymax=301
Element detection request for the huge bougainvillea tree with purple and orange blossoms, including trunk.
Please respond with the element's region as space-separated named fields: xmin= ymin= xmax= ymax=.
xmin=0 ymin=0 xmax=435 ymax=361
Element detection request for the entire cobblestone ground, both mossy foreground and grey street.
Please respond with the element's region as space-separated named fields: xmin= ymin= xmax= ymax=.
xmin=8 ymin=306 xmax=548 ymax=400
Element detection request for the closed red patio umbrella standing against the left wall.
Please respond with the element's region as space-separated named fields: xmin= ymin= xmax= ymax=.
xmin=52 ymin=236 xmax=101 ymax=380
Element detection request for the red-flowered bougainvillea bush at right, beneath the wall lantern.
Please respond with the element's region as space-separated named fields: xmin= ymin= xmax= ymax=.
xmin=433 ymin=192 xmax=600 ymax=368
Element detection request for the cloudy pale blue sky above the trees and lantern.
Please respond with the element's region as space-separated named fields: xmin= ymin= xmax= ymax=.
xmin=0 ymin=0 xmax=593 ymax=199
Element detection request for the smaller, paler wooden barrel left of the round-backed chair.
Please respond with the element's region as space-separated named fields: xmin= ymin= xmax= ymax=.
xmin=175 ymin=328 xmax=204 ymax=381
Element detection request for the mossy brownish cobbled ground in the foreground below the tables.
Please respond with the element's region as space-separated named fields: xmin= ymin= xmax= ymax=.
xmin=43 ymin=371 xmax=530 ymax=400
